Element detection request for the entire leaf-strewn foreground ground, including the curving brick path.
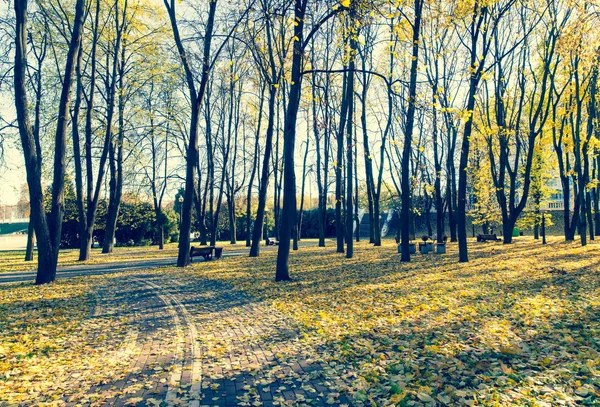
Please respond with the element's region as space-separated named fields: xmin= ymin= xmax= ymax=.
xmin=0 ymin=240 xmax=600 ymax=407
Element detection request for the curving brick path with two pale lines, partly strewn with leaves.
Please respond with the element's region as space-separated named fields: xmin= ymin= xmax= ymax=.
xmin=69 ymin=273 xmax=352 ymax=407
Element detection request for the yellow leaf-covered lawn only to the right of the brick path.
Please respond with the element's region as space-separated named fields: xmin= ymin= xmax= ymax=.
xmin=189 ymin=238 xmax=600 ymax=406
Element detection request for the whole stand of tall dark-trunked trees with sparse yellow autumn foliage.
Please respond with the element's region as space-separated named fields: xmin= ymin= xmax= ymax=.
xmin=2 ymin=0 xmax=600 ymax=283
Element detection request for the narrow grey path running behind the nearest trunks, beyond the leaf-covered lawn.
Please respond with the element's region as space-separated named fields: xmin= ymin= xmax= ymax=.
xmin=0 ymin=242 xmax=317 ymax=284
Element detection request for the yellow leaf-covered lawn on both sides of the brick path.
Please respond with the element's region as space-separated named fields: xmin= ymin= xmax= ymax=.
xmin=0 ymin=239 xmax=600 ymax=406
